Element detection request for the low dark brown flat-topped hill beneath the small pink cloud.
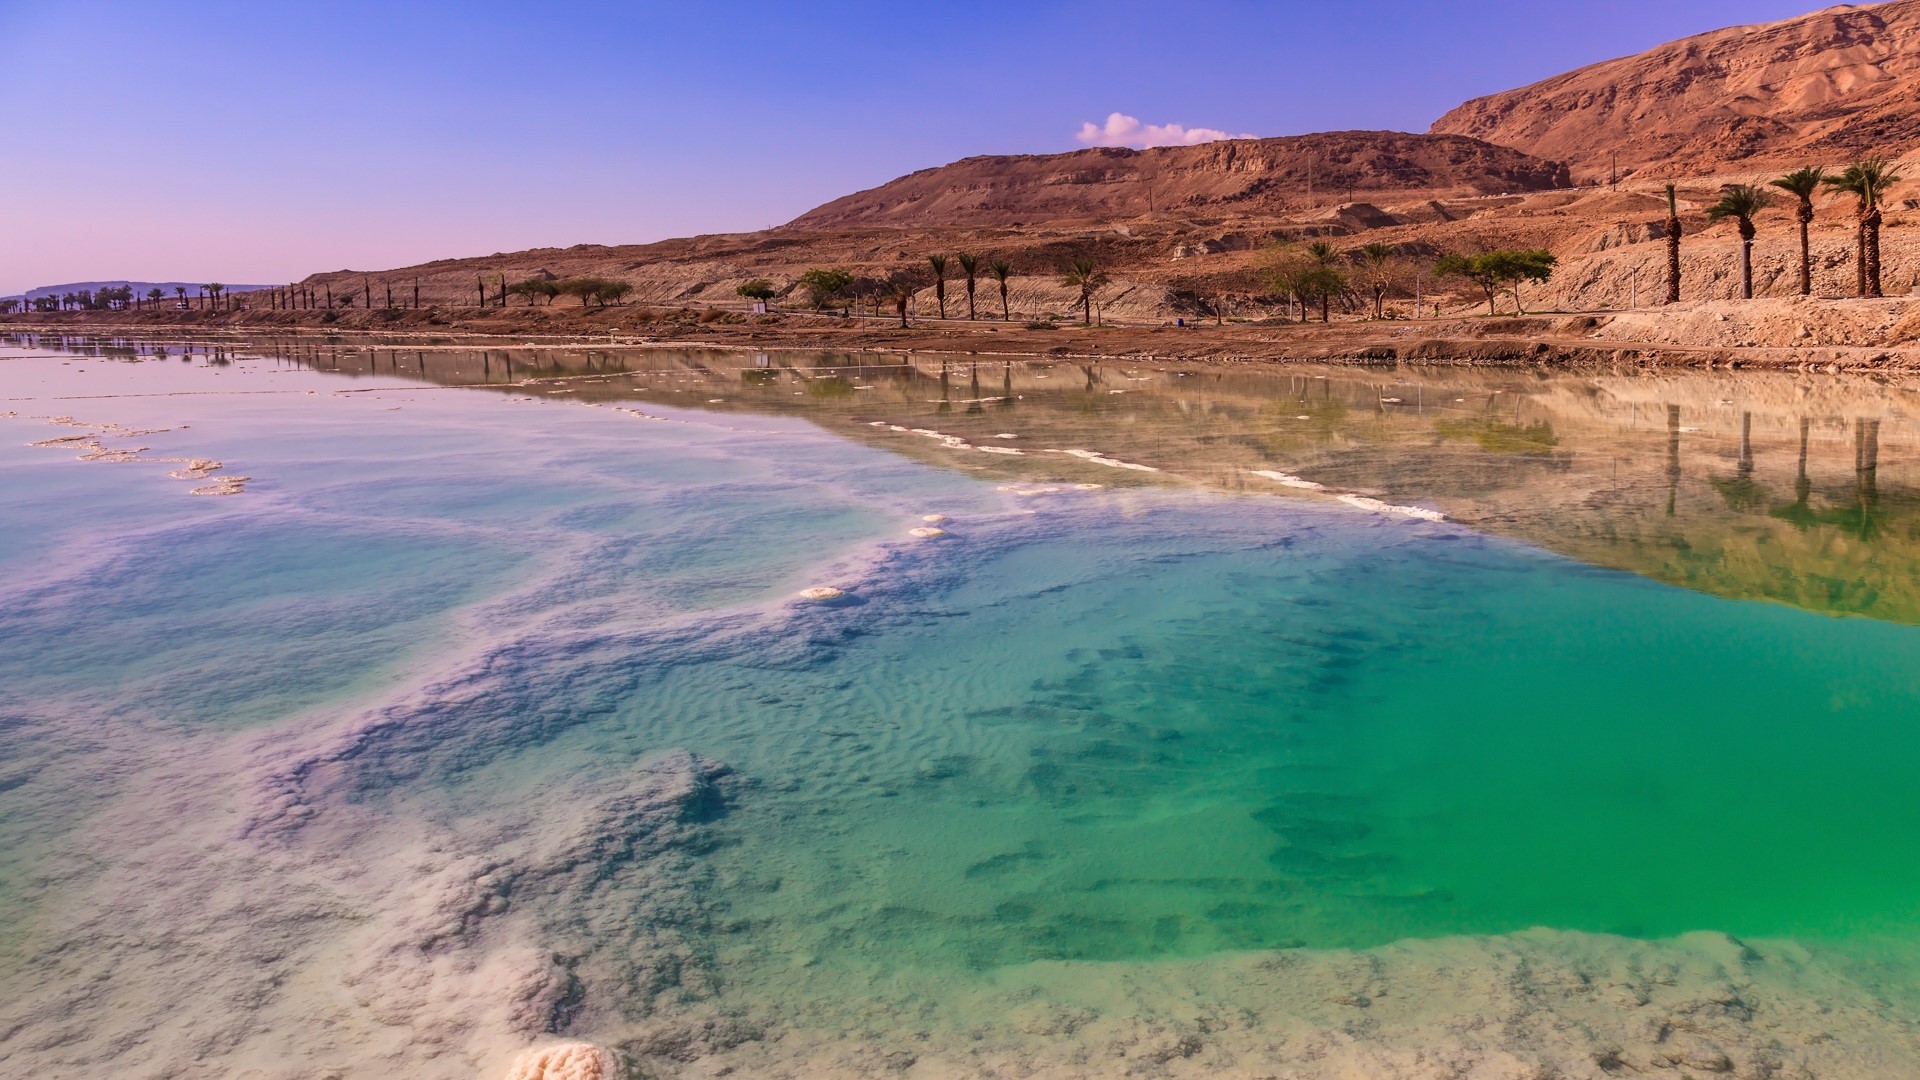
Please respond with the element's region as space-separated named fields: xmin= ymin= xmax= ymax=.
xmin=791 ymin=131 xmax=1571 ymax=229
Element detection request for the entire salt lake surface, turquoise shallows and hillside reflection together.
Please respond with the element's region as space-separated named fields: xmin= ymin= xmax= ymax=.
xmin=0 ymin=332 xmax=1920 ymax=1076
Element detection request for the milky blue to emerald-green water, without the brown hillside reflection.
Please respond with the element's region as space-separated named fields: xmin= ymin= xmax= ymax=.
xmin=0 ymin=332 xmax=1920 ymax=1068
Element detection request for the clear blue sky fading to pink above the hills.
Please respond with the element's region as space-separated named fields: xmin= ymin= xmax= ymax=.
xmin=0 ymin=0 xmax=1811 ymax=292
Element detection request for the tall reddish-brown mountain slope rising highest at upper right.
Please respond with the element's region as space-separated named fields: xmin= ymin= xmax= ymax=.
xmin=1432 ymin=0 xmax=1920 ymax=181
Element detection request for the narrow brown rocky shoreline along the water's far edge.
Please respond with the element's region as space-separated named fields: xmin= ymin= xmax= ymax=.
xmin=0 ymin=298 xmax=1920 ymax=373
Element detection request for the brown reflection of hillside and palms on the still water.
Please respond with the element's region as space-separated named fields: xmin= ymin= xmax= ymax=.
xmin=206 ymin=334 xmax=1920 ymax=623
